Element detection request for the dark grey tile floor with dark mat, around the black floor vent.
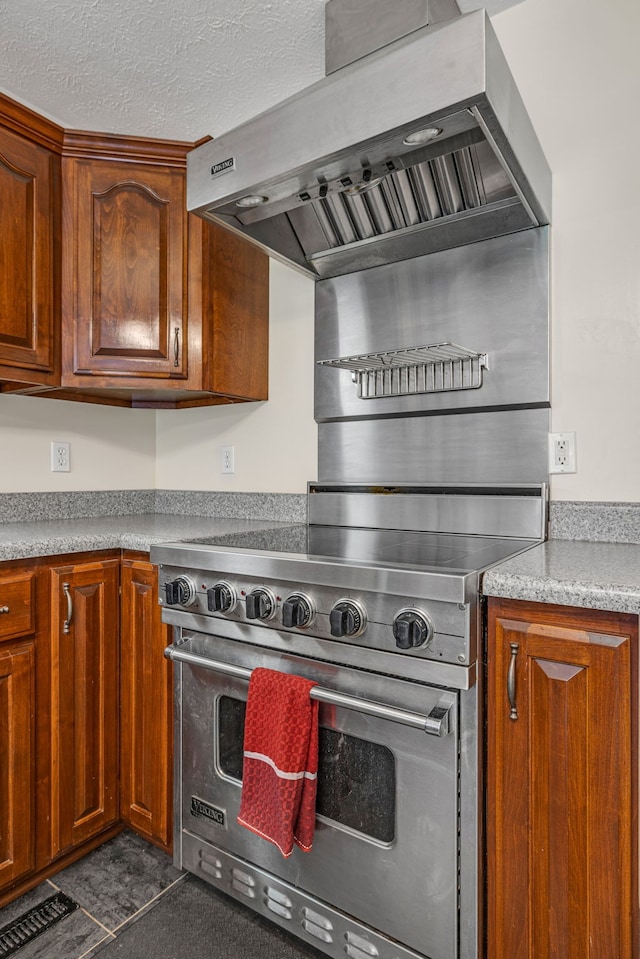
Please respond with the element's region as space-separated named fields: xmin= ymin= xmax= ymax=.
xmin=0 ymin=832 xmax=326 ymax=959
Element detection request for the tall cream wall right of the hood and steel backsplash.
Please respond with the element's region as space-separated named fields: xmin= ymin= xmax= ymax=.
xmin=493 ymin=0 xmax=640 ymax=501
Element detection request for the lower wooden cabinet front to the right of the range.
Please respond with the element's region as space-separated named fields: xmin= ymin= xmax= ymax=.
xmin=487 ymin=600 xmax=637 ymax=959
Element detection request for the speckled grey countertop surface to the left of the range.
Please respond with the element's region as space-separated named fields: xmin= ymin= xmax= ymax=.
xmin=0 ymin=513 xmax=298 ymax=561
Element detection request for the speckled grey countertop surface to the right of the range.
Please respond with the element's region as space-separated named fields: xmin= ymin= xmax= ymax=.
xmin=482 ymin=539 xmax=640 ymax=613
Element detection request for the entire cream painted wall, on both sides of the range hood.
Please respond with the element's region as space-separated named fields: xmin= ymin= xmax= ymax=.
xmin=0 ymin=0 xmax=640 ymax=501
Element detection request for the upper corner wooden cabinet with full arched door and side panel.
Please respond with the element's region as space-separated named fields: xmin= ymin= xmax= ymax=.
xmin=55 ymin=133 xmax=269 ymax=406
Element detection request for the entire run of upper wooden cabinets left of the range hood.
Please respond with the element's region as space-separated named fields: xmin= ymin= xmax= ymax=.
xmin=0 ymin=95 xmax=269 ymax=407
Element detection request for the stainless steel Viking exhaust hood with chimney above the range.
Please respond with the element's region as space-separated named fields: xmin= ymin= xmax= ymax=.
xmin=187 ymin=0 xmax=551 ymax=279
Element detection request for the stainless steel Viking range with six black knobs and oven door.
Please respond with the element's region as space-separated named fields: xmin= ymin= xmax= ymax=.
xmin=153 ymin=485 xmax=545 ymax=959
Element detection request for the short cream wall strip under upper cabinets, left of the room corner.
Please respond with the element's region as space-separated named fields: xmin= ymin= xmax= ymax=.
xmin=0 ymin=396 xmax=155 ymax=493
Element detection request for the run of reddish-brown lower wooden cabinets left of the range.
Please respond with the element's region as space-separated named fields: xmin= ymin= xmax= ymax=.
xmin=0 ymin=551 xmax=173 ymax=907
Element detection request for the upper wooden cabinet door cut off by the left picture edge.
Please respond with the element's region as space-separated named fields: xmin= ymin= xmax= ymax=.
xmin=0 ymin=128 xmax=59 ymax=383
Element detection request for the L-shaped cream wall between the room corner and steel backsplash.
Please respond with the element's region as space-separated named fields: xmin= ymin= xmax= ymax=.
xmin=156 ymin=260 xmax=317 ymax=493
